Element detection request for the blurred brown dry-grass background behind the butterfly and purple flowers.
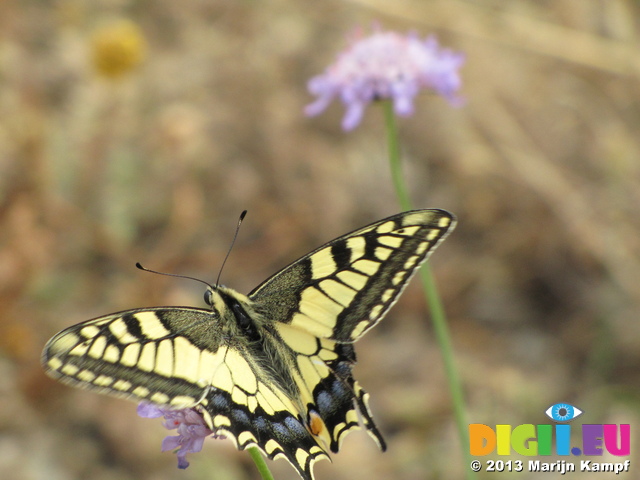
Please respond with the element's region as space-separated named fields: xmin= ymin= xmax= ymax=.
xmin=0 ymin=0 xmax=640 ymax=480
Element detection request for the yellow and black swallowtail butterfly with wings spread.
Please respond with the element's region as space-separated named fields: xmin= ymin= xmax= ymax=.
xmin=42 ymin=210 xmax=455 ymax=480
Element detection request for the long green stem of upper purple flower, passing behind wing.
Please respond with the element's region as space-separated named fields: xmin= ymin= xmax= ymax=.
xmin=382 ymin=101 xmax=476 ymax=479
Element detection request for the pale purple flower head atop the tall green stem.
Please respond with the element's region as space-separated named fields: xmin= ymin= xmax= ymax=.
xmin=305 ymin=27 xmax=464 ymax=130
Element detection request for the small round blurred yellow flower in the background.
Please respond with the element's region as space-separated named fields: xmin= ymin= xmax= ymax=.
xmin=91 ymin=20 xmax=147 ymax=78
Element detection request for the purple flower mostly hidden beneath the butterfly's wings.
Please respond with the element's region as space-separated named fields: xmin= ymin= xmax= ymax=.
xmin=138 ymin=402 xmax=215 ymax=468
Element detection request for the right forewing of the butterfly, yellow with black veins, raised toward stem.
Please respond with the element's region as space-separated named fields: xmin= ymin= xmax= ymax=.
xmin=249 ymin=210 xmax=455 ymax=342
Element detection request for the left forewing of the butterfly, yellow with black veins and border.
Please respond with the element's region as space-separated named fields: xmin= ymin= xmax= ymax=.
xmin=42 ymin=307 xmax=225 ymax=408
